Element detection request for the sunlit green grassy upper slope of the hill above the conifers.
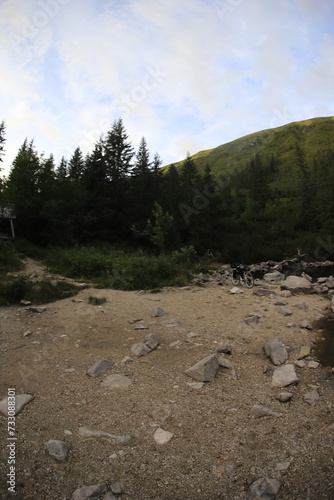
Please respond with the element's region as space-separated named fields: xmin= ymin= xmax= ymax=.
xmin=165 ymin=117 xmax=334 ymax=183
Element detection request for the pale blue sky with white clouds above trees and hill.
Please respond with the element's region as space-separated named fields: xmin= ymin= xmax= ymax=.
xmin=0 ymin=0 xmax=334 ymax=174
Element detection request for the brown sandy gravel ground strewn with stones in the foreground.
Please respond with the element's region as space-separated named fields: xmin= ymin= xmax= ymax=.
xmin=0 ymin=262 xmax=334 ymax=500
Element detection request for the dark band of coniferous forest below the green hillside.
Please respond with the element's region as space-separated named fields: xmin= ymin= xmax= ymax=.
xmin=0 ymin=119 xmax=334 ymax=262
